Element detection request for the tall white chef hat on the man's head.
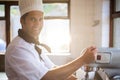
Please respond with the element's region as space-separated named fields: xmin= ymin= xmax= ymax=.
xmin=19 ymin=0 xmax=43 ymax=16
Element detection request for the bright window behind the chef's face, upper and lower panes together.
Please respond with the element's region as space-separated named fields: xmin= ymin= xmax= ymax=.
xmin=40 ymin=2 xmax=70 ymax=53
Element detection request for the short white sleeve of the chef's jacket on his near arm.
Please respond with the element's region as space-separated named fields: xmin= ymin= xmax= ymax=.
xmin=8 ymin=47 xmax=49 ymax=80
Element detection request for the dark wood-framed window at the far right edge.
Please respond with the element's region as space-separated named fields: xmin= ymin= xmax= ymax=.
xmin=110 ymin=0 xmax=120 ymax=48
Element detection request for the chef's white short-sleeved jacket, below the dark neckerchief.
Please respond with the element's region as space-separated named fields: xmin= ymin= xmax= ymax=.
xmin=5 ymin=36 xmax=55 ymax=80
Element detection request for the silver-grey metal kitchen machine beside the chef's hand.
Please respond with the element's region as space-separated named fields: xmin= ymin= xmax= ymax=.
xmin=82 ymin=48 xmax=120 ymax=80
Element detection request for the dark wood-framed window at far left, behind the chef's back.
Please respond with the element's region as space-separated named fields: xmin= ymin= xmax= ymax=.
xmin=0 ymin=1 xmax=18 ymax=54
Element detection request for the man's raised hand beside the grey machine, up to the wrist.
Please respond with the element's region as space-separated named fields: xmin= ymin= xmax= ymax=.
xmin=81 ymin=46 xmax=97 ymax=64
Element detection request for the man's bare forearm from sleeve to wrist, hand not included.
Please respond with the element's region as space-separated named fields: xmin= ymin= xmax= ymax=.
xmin=42 ymin=58 xmax=84 ymax=80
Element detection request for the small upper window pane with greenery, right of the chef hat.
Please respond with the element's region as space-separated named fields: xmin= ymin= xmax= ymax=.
xmin=43 ymin=3 xmax=68 ymax=18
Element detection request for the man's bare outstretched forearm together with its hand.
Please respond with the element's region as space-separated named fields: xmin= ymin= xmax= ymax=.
xmin=42 ymin=47 xmax=97 ymax=80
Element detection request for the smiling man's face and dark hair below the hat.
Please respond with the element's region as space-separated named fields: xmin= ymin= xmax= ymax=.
xmin=21 ymin=11 xmax=43 ymax=39
